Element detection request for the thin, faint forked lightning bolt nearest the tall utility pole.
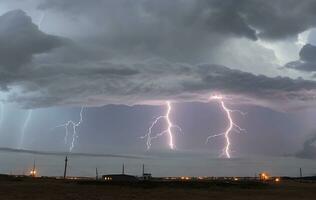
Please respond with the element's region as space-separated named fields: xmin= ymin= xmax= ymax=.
xmin=56 ymin=107 xmax=84 ymax=152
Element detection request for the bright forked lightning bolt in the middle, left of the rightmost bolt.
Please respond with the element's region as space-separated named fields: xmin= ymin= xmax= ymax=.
xmin=141 ymin=101 xmax=182 ymax=150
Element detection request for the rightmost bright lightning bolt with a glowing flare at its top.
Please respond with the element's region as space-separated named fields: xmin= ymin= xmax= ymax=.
xmin=206 ymin=95 xmax=246 ymax=158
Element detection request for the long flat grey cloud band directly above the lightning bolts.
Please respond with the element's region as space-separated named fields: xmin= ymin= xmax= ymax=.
xmin=3 ymin=60 xmax=316 ymax=107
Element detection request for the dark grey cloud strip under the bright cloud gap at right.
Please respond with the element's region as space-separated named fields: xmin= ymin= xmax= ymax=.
xmin=185 ymin=65 xmax=316 ymax=100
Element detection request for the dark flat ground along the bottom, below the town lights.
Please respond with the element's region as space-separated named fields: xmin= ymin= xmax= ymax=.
xmin=0 ymin=179 xmax=316 ymax=200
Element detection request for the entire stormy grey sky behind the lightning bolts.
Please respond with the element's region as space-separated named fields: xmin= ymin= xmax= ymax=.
xmin=0 ymin=0 xmax=316 ymax=175
